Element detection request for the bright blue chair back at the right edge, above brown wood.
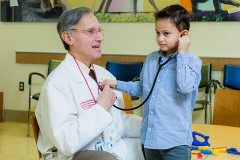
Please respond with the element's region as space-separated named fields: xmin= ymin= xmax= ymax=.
xmin=223 ymin=64 xmax=240 ymax=90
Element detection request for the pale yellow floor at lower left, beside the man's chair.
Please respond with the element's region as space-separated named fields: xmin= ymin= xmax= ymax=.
xmin=0 ymin=122 xmax=39 ymax=160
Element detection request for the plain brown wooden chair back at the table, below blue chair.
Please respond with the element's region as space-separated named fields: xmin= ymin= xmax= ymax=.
xmin=213 ymin=89 xmax=240 ymax=127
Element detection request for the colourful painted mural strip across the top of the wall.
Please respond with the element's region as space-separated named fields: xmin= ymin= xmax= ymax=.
xmin=0 ymin=0 xmax=240 ymax=22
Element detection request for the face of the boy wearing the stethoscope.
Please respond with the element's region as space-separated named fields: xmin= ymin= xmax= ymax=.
xmin=155 ymin=19 xmax=181 ymax=56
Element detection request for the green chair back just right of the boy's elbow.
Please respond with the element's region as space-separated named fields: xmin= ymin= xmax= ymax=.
xmin=199 ymin=63 xmax=212 ymax=88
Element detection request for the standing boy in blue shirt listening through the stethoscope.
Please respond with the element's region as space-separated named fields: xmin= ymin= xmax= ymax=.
xmin=101 ymin=5 xmax=202 ymax=160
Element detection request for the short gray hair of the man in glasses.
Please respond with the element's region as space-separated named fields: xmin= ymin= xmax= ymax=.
xmin=57 ymin=7 xmax=92 ymax=51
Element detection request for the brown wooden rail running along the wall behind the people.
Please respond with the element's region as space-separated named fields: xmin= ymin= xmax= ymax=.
xmin=16 ymin=52 xmax=240 ymax=71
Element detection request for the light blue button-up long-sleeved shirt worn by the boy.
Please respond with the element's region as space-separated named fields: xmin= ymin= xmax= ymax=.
xmin=116 ymin=51 xmax=202 ymax=149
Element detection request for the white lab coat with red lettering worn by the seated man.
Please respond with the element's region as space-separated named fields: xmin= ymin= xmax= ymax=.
xmin=35 ymin=53 xmax=143 ymax=160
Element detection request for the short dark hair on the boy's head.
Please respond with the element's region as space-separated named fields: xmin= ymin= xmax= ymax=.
xmin=154 ymin=4 xmax=190 ymax=31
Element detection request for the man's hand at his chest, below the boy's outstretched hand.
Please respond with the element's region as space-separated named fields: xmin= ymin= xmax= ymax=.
xmin=97 ymin=85 xmax=116 ymax=110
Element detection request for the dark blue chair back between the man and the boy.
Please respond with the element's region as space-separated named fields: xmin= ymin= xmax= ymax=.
xmin=106 ymin=61 xmax=143 ymax=81
